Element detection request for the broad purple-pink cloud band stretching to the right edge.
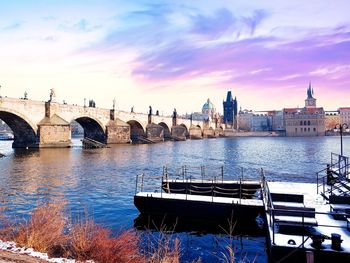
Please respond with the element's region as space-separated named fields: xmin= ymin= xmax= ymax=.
xmin=133 ymin=26 xmax=350 ymax=91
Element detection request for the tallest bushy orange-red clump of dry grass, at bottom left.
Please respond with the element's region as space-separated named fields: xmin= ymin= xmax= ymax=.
xmin=14 ymin=202 xmax=67 ymax=255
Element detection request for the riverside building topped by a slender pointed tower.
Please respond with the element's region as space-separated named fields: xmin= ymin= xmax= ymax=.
xmin=283 ymin=84 xmax=325 ymax=136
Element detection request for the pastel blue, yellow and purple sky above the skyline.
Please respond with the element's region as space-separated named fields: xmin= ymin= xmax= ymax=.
xmin=0 ymin=0 xmax=350 ymax=115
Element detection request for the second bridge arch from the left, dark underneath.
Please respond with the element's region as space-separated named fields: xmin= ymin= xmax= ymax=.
xmin=72 ymin=116 xmax=107 ymax=143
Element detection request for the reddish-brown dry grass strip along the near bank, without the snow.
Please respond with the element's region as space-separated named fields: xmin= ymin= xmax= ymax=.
xmin=0 ymin=201 xmax=185 ymax=263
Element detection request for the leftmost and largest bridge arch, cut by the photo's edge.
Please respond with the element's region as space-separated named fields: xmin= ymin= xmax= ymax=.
xmin=0 ymin=109 xmax=39 ymax=148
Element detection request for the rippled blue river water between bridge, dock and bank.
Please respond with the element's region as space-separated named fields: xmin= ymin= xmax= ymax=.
xmin=0 ymin=137 xmax=350 ymax=262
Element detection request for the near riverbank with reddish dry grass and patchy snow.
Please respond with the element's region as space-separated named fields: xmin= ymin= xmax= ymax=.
xmin=0 ymin=201 xmax=180 ymax=263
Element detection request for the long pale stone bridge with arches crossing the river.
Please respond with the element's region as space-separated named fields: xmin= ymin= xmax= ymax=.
xmin=0 ymin=97 xmax=223 ymax=148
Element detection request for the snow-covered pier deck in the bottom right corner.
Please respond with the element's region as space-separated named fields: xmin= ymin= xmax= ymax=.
xmin=265 ymin=182 xmax=350 ymax=262
